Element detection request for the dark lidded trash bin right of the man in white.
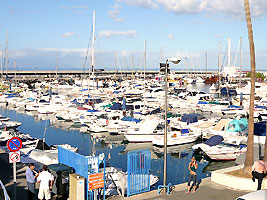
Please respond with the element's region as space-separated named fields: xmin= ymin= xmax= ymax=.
xmin=48 ymin=164 xmax=74 ymax=195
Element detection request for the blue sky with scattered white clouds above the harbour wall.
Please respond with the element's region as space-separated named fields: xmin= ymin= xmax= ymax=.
xmin=0 ymin=0 xmax=267 ymax=71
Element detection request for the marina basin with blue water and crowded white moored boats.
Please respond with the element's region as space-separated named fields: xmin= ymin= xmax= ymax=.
xmin=0 ymin=69 xmax=266 ymax=200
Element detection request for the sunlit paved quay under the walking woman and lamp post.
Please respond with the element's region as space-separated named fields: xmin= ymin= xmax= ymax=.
xmin=108 ymin=178 xmax=248 ymax=200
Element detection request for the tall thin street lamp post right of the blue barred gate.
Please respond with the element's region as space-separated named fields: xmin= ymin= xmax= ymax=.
xmin=163 ymin=58 xmax=181 ymax=193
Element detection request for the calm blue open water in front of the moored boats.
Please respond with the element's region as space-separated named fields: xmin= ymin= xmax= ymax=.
xmin=0 ymin=108 xmax=214 ymax=186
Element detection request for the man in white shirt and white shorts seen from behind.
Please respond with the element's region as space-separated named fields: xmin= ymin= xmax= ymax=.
xmin=37 ymin=165 xmax=54 ymax=200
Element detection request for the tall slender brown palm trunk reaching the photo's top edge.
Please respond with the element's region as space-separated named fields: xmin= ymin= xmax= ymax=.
xmin=243 ymin=0 xmax=256 ymax=174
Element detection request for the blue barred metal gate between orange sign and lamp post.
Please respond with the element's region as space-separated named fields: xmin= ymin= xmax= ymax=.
xmin=127 ymin=149 xmax=151 ymax=197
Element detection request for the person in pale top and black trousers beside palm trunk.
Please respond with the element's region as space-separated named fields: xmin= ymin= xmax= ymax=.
xmin=252 ymin=156 xmax=267 ymax=190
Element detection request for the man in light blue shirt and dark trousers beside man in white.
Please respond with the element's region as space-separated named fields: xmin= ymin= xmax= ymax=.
xmin=26 ymin=163 xmax=39 ymax=200
